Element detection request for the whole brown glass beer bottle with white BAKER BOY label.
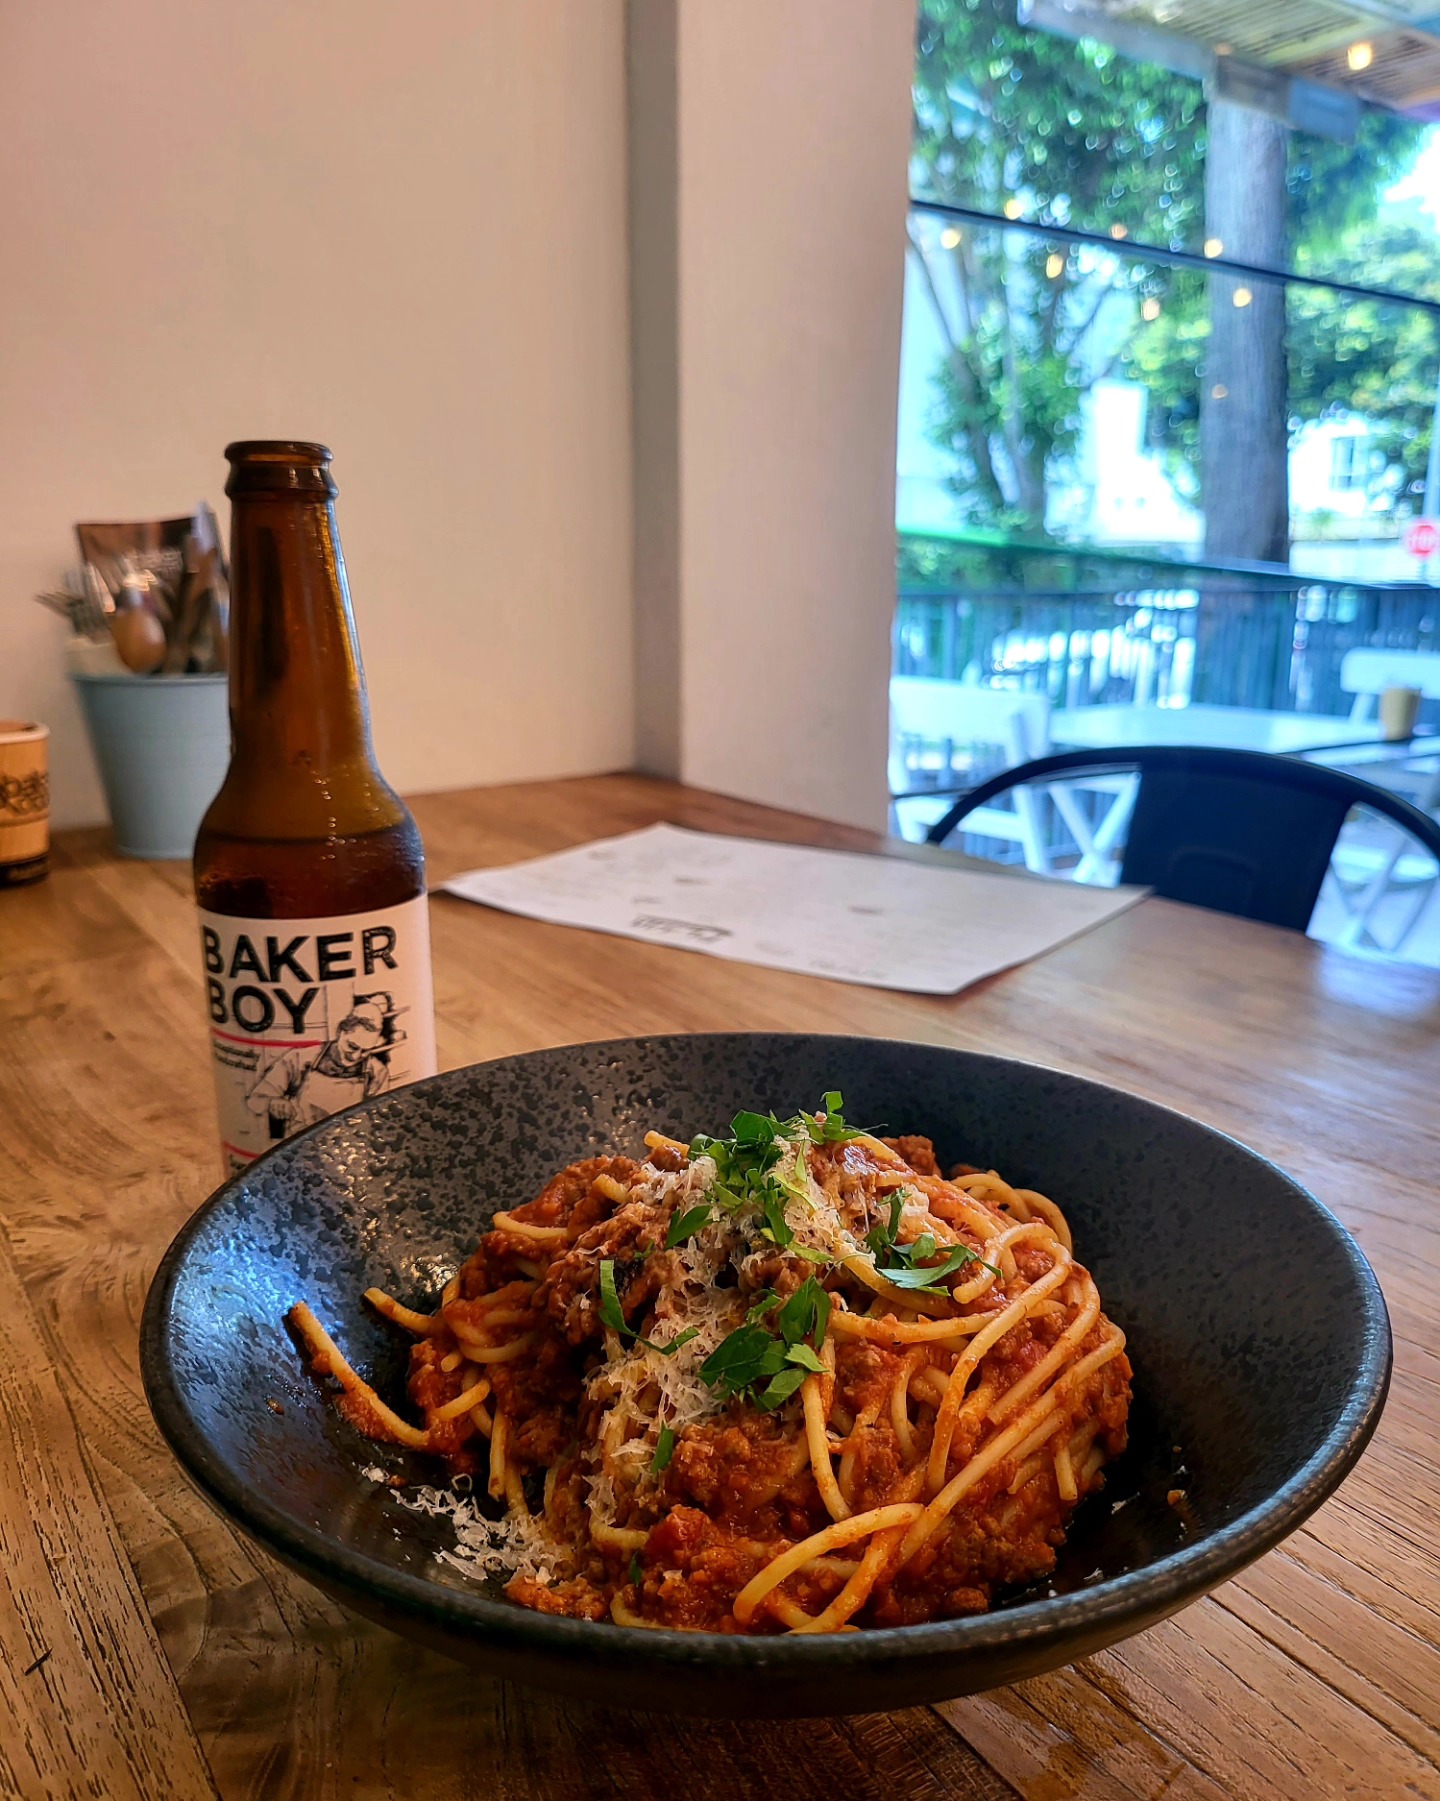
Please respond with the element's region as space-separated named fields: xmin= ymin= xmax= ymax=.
xmin=194 ymin=441 xmax=436 ymax=1171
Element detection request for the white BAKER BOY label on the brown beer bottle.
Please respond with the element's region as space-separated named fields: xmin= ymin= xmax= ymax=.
xmin=200 ymin=895 xmax=436 ymax=1174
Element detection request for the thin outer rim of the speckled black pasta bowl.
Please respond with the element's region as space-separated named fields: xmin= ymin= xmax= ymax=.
xmin=140 ymin=1032 xmax=1391 ymax=1682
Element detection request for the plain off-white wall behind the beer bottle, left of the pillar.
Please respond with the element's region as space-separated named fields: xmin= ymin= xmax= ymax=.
xmin=0 ymin=0 xmax=630 ymax=823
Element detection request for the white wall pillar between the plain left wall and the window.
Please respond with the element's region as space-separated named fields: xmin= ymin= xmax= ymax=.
xmin=632 ymin=0 xmax=914 ymax=827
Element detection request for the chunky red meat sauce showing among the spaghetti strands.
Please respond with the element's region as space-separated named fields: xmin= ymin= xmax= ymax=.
xmin=399 ymin=1138 xmax=1130 ymax=1632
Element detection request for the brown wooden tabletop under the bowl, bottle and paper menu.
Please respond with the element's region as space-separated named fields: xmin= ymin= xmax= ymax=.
xmin=0 ymin=776 xmax=1440 ymax=1801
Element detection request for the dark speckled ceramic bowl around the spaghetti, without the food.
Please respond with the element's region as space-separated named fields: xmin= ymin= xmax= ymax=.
xmin=142 ymin=1034 xmax=1390 ymax=1715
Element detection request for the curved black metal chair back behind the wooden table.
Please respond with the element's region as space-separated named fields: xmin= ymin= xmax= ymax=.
xmin=925 ymin=744 xmax=1440 ymax=931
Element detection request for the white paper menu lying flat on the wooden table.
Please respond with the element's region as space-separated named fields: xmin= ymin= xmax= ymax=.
xmin=445 ymin=825 xmax=1145 ymax=994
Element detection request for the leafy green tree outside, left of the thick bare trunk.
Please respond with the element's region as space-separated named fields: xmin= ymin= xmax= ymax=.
xmin=911 ymin=0 xmax=1204 ymax=531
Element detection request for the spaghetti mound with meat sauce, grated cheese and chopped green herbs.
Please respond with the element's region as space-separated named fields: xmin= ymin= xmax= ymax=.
xmin=290 ymin=1095 xmax=1130 ymax=1634
